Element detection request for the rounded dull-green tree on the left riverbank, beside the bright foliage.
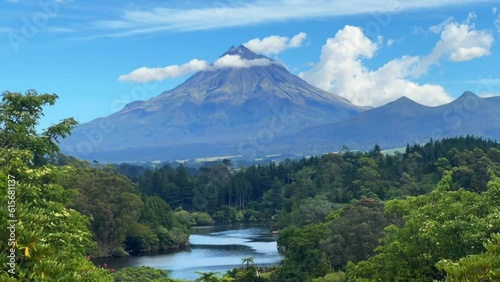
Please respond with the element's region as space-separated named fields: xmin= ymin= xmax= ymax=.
xmin=62 ymin=165 xmax=143 ymax=256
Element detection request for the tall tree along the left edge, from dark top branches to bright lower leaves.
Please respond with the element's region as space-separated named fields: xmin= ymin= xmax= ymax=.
xmin=0 ymin=90 xmax=112 ymax=281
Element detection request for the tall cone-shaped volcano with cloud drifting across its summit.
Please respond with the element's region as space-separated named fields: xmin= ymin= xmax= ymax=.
xmin=61 ymin=46 xmax=365 ymax=161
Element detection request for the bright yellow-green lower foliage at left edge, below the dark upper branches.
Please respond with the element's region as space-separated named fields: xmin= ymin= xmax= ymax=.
xmin=0 ymin=158 xmax=111 ymax=281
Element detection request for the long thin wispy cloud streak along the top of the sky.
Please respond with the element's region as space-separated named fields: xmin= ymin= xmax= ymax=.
xmin=91 ymin=0 xmax=486 ymax=38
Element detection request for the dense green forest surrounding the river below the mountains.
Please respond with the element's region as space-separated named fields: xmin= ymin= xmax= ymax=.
xmin=0 ymin=91 xmax=500 ymax=281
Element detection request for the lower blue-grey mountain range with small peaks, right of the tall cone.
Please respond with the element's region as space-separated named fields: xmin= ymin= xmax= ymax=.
xmin=284 ymin=91 xmax=500 ymax=154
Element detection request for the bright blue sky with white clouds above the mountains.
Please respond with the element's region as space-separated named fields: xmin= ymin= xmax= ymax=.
xmin=0 ymin=0 xmax=500 ymax=128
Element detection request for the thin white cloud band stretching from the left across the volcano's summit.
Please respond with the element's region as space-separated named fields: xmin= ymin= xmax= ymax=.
xmin=118 ymin=55 xmax=272 ymax=83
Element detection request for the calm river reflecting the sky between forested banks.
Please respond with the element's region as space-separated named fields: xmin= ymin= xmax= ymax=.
xmin=94 ymin=225 xmax=281 ymax=280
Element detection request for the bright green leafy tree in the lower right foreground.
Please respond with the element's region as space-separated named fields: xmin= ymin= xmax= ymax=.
xmin=348 ymin=176 xmax=500 ymax=281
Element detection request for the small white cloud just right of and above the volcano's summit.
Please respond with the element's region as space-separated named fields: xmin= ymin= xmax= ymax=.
xmin=243 ymin=32 xmax=307 ymax=55
